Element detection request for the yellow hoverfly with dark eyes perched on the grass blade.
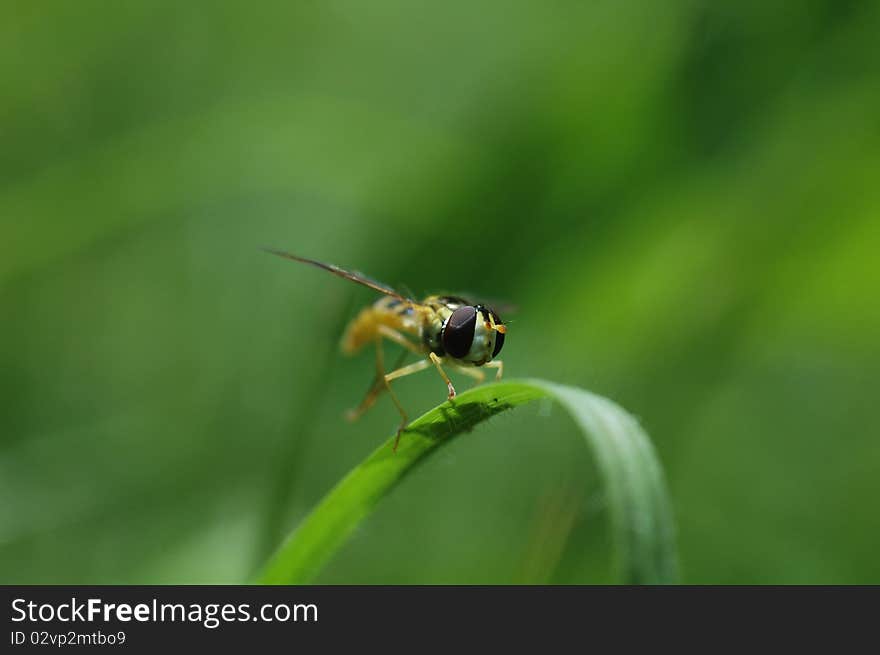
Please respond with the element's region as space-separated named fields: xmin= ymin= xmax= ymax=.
xmin=265 ymin=248 xmax=507 ymax=450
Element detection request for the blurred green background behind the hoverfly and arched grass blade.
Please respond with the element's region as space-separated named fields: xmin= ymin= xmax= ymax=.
xmin=0 ymin=0 xmax=880 ymax=583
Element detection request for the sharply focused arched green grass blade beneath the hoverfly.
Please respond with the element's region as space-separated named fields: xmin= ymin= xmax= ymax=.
xmin=257 ymin=379 xmax=677 ymax=584
